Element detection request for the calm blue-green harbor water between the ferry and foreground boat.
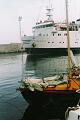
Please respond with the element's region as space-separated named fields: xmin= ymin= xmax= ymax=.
xmin=0 ymin=53 xmax=80 ymax=120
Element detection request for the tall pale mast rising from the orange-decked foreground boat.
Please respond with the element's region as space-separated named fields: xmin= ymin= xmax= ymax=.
xmin=65 ymin=0 xmax=71 ymax=77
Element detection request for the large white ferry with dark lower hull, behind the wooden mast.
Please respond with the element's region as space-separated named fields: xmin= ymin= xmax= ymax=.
xmin=22 ymin=4 xmax=80 ymax=55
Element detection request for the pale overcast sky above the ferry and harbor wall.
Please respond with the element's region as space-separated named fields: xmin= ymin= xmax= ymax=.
xmin=0 ymin=0 xmax=80 ymax=44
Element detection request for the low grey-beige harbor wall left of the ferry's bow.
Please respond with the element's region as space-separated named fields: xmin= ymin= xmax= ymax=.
xmin=0 ymin=43 xmax=22 ymax=53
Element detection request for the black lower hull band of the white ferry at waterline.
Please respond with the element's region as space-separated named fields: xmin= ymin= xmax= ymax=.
xmin=25 ymin=48 xmax=80 ymax=56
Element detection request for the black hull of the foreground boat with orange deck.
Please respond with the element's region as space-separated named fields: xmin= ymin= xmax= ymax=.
xmin=20 ymin=89 xmax=79 ymax=118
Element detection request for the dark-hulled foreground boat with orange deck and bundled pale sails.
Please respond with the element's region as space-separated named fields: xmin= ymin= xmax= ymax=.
xmin=19 ymin=73 xmax=80 ymax=118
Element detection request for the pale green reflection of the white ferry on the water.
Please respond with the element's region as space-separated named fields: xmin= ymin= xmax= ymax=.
xmin=25 ymin=56 xmax=67 ymax=77
